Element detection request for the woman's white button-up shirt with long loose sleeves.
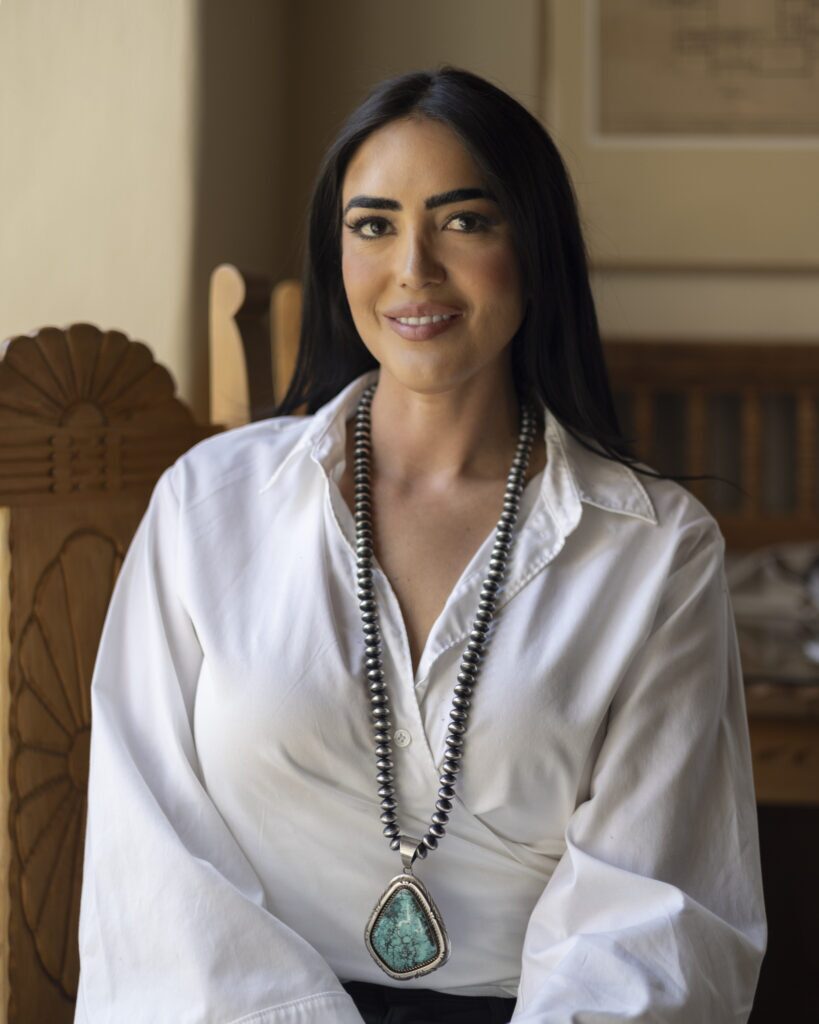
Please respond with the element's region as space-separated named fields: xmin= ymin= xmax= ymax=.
xmin=76 ymin=370 xmax=766 ymax=1024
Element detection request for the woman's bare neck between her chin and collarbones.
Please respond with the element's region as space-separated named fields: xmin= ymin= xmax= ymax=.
xmin=371 ymin=368 xmax=532 ymax=493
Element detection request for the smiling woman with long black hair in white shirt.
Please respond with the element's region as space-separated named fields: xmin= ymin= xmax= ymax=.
xmin=77 ymin=67 xmax=766 ymax=1024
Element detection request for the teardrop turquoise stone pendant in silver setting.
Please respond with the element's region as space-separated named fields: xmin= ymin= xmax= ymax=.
xmin=364 ymin=866 xmax=449 ymax=981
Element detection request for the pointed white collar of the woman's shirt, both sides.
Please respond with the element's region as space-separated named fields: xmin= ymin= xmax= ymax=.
xmin=259 ymin=367 xmax=657 ymax=536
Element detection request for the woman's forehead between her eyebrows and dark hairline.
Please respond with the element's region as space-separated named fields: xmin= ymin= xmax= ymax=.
xmin=342 ymin=119 xmax=483 ymax=202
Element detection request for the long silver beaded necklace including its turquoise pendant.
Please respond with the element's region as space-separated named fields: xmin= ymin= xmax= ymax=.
xmin=354 ymin=383 xmax=536 ymax=981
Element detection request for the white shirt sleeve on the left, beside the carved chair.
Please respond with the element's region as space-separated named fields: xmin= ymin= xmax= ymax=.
xmin=75 ymin=467 xmax=361 ymax=1024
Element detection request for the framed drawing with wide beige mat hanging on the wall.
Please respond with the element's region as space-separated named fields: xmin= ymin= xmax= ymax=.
xmin=544 ymin=0 xmax=819 ymax=270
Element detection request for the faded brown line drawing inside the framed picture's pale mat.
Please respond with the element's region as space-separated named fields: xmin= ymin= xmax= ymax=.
xmin=593 ymin=0 xmax=819 ymax=138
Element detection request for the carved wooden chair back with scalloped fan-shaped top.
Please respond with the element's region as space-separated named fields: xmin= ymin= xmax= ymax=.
xmin=0 ymin=324 xmax=222 ymax=1024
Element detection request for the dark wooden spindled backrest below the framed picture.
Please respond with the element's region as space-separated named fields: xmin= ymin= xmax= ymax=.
xmin=606 ymin=341 xmax=819 ymax=550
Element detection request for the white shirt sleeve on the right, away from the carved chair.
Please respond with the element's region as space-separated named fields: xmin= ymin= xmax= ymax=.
xmin=513 ymin=519 xmax=767 ymax=1024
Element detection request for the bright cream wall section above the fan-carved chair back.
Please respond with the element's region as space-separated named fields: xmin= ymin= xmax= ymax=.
xmin=0 ymin=0 xmax=198 ymax=407
